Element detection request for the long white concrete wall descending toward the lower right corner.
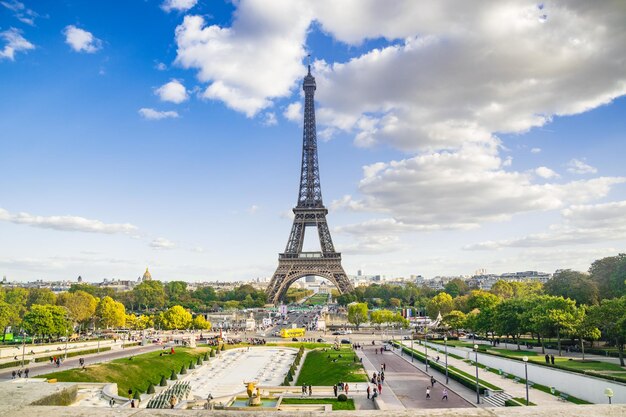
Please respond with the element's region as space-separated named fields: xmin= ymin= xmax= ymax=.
xmin=420 ymin=343 xmax=626 ymax=404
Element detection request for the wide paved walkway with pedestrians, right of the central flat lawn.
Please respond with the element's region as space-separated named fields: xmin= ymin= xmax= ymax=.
xmin=359 ymin=346 xmax=472 ymax=409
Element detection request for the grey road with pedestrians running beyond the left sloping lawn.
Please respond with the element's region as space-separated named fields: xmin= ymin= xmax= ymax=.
xmin=0 ymin=344 xmax=163 ymax=381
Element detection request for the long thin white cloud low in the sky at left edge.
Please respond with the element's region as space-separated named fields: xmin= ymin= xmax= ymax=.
xmin=0 ymin=208 xmax=138 ymax=234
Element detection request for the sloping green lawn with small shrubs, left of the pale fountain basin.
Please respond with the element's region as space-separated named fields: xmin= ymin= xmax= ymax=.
xmin=42 ymin=347 xmax=208 ymax=395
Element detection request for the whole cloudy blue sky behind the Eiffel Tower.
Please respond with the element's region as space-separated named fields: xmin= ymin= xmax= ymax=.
xmin=0 ymin=0 xmax=626 ymax=281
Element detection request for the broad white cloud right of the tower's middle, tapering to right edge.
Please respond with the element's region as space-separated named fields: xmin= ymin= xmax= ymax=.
xmin=331 ymin=145 xmax=626 ymax=228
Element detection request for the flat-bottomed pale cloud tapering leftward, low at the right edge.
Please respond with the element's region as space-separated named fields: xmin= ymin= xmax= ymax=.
xmin=465 ymin=201 xmax=626 ymax=250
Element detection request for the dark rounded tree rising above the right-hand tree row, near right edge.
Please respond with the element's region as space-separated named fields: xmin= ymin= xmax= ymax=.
xmin=543 ymin=269 xmax=598 ymax=305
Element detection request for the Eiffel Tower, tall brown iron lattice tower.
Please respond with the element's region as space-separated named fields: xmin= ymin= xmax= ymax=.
xmin=267 ymin=65 xmax=352 ymax=304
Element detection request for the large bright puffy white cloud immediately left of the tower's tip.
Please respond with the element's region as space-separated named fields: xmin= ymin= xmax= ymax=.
xmin=176 ymin=0 xmax=311 ymax=117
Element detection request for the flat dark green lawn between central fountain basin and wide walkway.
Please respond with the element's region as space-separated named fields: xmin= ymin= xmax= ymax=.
xmin=295 ymin=348 xmax=367 ymax=385
